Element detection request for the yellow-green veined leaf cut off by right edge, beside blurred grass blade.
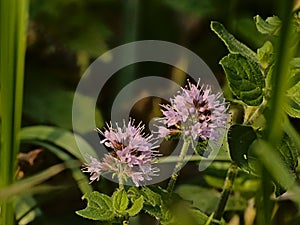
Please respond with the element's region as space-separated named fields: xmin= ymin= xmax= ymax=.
xmin=284 ymin=69 xmax=300 ymax=118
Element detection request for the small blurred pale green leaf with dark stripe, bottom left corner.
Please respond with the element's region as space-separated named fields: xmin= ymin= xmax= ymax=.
xmin=15 ymin=195 xmax=42 ymax=225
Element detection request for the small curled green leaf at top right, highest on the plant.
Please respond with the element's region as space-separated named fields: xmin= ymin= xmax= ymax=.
xmin=254 ymin=15 xmax=281 ymax=35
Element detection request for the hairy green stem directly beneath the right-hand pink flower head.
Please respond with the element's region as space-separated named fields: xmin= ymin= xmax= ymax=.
xmin=167 ymin=140 xmax=190 ymax=195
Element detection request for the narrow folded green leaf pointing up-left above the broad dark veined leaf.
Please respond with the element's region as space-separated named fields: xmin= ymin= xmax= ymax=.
xmin=210 ymin=21 xmax=257 ymax=62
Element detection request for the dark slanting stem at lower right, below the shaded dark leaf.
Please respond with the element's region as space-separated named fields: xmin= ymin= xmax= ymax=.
xmin=214 ymin=163 xmax=238 ymax=220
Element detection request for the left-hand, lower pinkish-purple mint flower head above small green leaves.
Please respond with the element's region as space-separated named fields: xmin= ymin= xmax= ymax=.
xmin=83 ymin=121 xmax=159 ymax=186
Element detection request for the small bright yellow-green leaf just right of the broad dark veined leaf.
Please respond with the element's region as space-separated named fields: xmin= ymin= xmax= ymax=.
xmin=257 ymin=41 xmax=274 ymax=69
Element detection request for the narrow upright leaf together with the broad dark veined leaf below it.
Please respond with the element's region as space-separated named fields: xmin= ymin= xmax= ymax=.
xmin=211 ymin=22 xmax=265 ymax=106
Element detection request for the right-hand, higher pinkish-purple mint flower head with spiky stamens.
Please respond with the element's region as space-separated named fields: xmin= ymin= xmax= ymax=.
xmin=157 ymin=80 xmax=227 ymax=142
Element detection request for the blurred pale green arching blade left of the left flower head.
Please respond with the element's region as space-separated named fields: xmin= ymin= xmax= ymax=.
xmin=21 ymin=126 xmax=96 ymax=160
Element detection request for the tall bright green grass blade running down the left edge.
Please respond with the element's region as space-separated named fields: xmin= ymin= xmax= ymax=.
xmin=0 ymin=0 xmax=28 ymax=225
